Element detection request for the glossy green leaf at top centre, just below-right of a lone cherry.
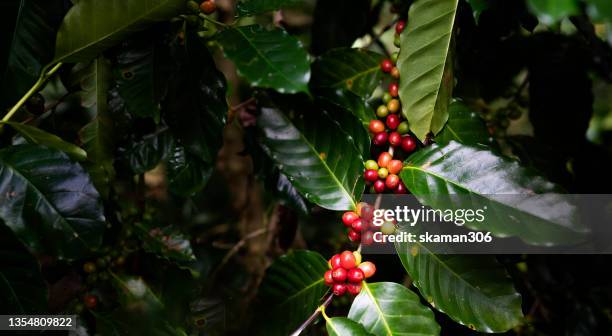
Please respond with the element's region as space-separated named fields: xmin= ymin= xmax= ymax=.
xmin=218 ymin=25 xmax=310 ymax=93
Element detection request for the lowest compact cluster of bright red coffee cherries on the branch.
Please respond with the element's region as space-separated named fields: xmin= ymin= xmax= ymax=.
xmin=323 ymin=251 xmax=376 ymax=296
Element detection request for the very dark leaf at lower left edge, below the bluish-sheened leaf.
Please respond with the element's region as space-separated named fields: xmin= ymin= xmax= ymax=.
xmin=0 ymin=221 xmax=47 ymax=314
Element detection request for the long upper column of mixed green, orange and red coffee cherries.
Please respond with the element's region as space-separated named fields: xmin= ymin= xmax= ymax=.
xmin=363 ymin=20 xmax=417 ymax=194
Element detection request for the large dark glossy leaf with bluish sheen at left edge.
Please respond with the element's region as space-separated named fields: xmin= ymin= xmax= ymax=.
xmin=0 ymin=145 xmax=105 ymax=258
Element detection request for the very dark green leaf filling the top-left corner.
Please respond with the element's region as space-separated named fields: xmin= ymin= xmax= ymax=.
xmin=0 ymin=0 xmax=64 ymax=108
